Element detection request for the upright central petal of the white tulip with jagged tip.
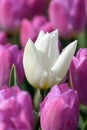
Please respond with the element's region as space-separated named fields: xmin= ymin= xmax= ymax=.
xmin=36 ymin=30 xmax=59 ymax=71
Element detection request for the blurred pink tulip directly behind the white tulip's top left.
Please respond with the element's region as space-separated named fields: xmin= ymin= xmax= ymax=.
xmin=20 ymin=16 xmax=53 ymax=47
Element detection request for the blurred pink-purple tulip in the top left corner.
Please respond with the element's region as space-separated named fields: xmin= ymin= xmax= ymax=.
xmin=0 ymin=0 xmax=23 ymax=30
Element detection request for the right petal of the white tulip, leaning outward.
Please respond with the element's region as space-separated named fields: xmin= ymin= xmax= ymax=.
xmin=51 ymin=40 xmax=77 ymax=83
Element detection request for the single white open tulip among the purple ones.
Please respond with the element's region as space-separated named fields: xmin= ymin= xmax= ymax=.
xmin=23 ymin=30 xmax=77 ymax=89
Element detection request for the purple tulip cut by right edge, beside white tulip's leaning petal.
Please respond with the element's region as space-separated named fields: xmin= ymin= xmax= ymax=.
xmin=70 ymin=49 xmax=87 ymax=105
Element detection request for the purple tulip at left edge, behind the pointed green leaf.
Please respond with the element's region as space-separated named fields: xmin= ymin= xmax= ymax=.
xmin=0 ymin=44 xmax=24 ymax=87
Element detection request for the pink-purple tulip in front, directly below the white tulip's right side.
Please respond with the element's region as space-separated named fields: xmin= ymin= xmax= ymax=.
xmin=40 ymin=84 xmax=79 ymax=130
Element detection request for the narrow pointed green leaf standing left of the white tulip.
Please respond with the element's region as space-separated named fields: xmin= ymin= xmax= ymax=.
xmin=9 ymin=64 xmax=17 ymax=87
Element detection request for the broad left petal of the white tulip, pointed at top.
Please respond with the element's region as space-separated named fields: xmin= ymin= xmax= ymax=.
xmin=23 ymin=39 xmax=47 ymax=87
